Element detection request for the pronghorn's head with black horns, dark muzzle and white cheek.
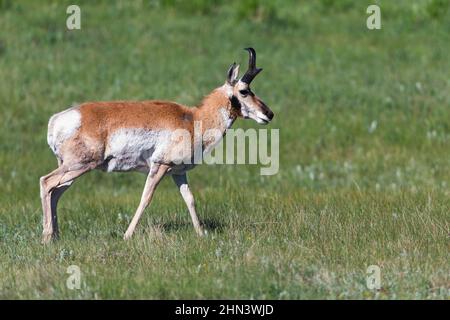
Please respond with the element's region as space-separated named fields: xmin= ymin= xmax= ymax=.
xmin=225 ymin=48 xmax=274 ymax=124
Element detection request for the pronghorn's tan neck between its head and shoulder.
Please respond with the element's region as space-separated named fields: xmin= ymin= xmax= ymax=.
xmin=194 ymin=85 xmax=238 ymax=134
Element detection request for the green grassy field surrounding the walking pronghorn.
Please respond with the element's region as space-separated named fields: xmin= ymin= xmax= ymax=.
xmin=0 ymin=0 xmax=450 ymax=299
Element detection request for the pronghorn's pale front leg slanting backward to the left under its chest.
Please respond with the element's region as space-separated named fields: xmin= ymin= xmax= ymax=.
xmin=123 ymin=163 xmax=169 ymax=240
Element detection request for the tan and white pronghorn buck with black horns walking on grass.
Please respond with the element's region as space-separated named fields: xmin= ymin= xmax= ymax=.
xmin=40 ymin=48 xmax=274 ymax=243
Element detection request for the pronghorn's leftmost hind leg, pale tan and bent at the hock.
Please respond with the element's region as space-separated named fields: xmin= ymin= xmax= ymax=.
xmin=40 ymin=165 xmax=93 ymax=243
